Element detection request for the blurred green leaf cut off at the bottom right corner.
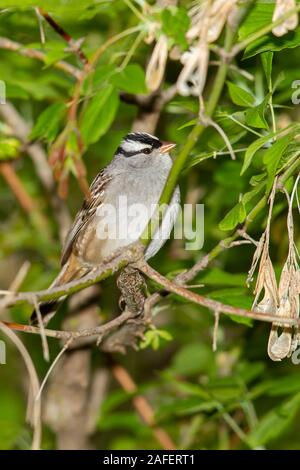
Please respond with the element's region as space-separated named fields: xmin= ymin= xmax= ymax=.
xmin=248 ymin=393 xmax=300 ymax=447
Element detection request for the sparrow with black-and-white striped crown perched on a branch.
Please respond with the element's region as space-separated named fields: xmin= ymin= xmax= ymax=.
xmin=30 ymin=132 xmax=180 ymax=325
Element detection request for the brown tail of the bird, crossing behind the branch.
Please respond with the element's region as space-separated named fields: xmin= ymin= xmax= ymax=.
xmin=30 ymin=255 xmax=89 ymax=325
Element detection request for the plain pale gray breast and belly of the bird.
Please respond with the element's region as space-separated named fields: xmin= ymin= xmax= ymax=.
xmin=96 ymin=159 xmax=180 ymax=258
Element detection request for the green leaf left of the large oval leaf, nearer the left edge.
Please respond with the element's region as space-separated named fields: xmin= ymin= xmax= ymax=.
xmin=30 ymin=103 xmax=66 ymax=142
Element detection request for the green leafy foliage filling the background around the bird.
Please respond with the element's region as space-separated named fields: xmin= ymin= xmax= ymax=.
xmin=0 ymin=0 xmax=300 ymax=449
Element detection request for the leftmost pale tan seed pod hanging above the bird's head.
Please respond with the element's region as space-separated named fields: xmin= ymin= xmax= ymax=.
xmin=146 ymin=34 xmax=168 ymax=91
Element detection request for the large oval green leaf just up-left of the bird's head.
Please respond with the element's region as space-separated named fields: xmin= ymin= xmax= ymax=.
xmin=80 ymin=85 xmax=119 ymax=145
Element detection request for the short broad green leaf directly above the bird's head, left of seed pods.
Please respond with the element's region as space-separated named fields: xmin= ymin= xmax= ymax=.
xmin=111 ymin=64 xmax=147 ymax=93
